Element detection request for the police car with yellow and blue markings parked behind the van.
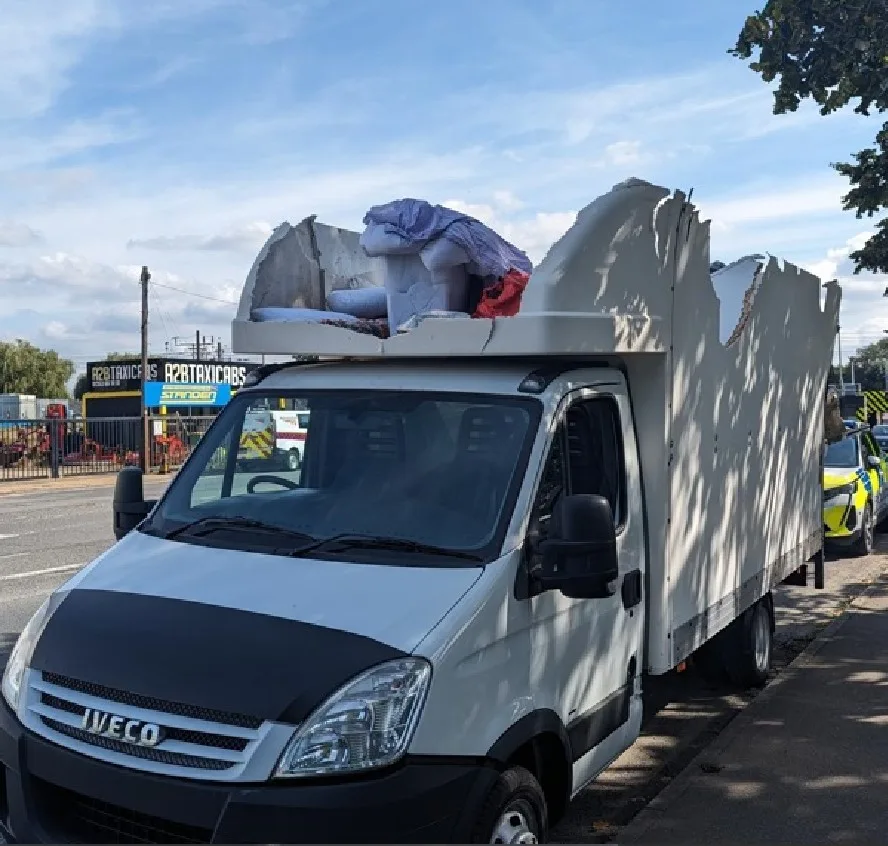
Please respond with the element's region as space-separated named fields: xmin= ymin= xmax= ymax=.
xmin=823 ymin=428 xmax=888 ymax=555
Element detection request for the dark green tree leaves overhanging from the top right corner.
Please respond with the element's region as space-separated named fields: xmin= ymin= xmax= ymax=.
xmin=729 ymin=0 xmax=888 ymax=273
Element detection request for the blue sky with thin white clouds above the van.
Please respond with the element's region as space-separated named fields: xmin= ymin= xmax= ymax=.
xmin=0 ymin=0 xmax=888 ymax=374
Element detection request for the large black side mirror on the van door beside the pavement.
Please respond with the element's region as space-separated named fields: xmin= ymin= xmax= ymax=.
xmin=539 ymin=494 xmax=620 ymax=599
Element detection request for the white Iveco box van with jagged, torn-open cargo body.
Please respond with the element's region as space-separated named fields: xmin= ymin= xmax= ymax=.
xmin=0 ymin=183 xmax=838 ymax=843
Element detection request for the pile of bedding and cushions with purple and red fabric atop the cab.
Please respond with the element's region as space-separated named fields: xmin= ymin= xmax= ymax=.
xmin=250 ymin=198 xmax=533 ymax=338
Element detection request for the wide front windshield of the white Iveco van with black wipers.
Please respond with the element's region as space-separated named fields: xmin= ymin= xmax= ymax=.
xmin=143 ymin=390 xmax=542 ymax=566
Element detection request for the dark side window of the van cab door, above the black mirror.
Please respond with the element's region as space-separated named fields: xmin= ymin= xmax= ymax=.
xmin=528 ymin=399 xmax=626 ymax=569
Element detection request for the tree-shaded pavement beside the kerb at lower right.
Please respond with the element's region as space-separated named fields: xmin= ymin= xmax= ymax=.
xmin=618 ymin=577 xmax=888 ymax=846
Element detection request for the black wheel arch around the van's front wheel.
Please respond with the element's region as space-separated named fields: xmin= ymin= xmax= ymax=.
xmin=487 ymin=709 xmax=573 ymax=825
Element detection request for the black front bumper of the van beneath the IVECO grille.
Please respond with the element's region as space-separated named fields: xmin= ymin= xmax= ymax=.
xmin=0 ymin=700 xmax=497 ymax=843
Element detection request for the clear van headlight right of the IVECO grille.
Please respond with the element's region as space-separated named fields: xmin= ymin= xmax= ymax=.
xmin=274 ymin=658 xmax=432 ymax=778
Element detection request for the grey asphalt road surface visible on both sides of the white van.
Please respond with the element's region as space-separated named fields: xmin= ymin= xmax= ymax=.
xmin=0 ymin=474 xmax=888 ymax=843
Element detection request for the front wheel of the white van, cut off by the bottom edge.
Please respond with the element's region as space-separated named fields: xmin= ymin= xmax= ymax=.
xmin=471 ymin=767 xmax=549 ymax=843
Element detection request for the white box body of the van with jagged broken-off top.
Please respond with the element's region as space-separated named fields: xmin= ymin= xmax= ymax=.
xmin=232 ymin=180 xmax=840 ymax=673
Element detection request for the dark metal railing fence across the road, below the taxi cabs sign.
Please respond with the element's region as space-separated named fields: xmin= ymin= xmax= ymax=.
xmin=0 ymin=415 xmax=213 ymax=483
